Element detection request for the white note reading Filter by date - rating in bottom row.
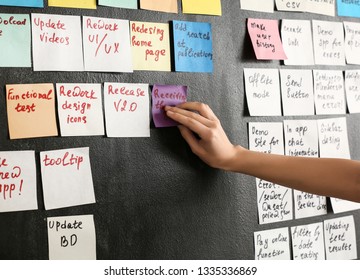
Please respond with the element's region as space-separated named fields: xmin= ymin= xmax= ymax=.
xmin=291 ymin=223 xmax=325 ymax=260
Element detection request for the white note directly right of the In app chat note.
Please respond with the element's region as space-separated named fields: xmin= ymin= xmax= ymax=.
xmin=317 ymin=117 xmax=350 ymax=159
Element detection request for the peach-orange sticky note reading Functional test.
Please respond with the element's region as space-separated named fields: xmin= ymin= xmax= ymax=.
xmin=6 ymin=84 xmax=58 ymax=139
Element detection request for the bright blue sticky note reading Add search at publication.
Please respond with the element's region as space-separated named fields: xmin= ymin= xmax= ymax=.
xmin=173 ymin=20 xmax=213 ymax=73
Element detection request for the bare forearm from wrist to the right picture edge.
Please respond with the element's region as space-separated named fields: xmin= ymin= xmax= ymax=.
xmin=225 ymin=147 xmax=360 ymax=202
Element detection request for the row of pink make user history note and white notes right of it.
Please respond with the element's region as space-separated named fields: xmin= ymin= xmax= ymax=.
xmin=248 ymin=18 xmax=360 ymax=65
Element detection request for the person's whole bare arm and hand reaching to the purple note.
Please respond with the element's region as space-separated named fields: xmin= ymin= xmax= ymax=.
xmin=165 ymin=102 xmax=360 ymax=202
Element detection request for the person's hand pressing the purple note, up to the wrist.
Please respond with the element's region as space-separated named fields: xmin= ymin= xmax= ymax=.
xmin=165 ymin=102 xmax=239 ymax=170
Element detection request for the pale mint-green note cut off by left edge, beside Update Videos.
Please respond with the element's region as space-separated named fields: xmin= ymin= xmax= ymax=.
xmin=0 ymin=14 xmax=31 ymax=67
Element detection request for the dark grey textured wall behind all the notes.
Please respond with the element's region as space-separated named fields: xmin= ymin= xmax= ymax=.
xmin=0 ymin=0 xmax=360 ymax=259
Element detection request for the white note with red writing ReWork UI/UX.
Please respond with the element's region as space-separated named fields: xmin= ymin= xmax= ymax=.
xmin=83 ymin=17 xmax=133 ymax=72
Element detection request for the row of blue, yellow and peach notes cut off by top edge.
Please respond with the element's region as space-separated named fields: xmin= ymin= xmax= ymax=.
xmin=0 ymin=0 xmax=222 ymax=16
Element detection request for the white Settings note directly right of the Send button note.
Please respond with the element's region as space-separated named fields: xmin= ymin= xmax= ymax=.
xmin=313 ymin=70 xmax=346 ymax=115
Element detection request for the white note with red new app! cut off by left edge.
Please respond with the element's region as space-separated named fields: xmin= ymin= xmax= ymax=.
xmin=0 ymin=151 xmax=38 ymax=212
